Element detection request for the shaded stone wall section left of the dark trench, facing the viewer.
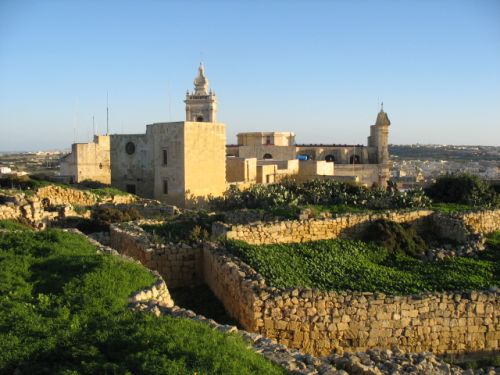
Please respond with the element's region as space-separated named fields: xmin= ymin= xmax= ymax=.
xmin=110 ymin=223 xmax=203 ymax=288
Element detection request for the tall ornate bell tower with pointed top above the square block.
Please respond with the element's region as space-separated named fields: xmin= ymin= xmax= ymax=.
xmin=184 ymin=63 xmax=217 ymax=122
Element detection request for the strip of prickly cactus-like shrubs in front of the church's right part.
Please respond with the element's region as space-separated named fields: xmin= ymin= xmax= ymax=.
xmin=210 ymin=180 xmax=430 ymax=211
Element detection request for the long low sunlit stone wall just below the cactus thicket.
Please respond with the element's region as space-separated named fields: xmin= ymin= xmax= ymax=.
xmin=212 ymin=210 xmax=433 ymax=244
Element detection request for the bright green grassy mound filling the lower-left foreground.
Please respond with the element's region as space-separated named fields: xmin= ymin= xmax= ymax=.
xmin=0 ymin=230 xmax=283 ymax=374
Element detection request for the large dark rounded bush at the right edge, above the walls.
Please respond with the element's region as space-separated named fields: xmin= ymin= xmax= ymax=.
xmin=426 ymin=173 xmax=500 ymax=207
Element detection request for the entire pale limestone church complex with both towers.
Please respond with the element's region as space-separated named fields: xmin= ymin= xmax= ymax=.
xmin=60 ymin=64 xmax=390 ymax=207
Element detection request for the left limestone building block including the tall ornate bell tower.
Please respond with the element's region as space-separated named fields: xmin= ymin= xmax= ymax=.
xmin=61 ymin=65 xmax=226 ymax=206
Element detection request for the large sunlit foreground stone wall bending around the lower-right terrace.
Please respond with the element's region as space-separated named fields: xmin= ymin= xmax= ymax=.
xmin=204 ymin=249 xmax=500 ymax=355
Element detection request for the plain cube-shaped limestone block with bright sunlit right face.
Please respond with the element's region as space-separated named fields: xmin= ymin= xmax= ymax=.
xmin=146 ymin=121 xmax=226 ymax=207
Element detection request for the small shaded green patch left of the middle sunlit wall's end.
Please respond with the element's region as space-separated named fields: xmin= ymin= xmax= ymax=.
xmin=142 ymin=211 xmax=222 ymax=243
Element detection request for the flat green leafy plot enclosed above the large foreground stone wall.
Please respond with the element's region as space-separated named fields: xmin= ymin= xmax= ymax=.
xmin=226 ymin=232 xmax=500 ymax=295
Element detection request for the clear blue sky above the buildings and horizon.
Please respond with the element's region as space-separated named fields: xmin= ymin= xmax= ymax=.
xmin=0 ymin=0 xmax=500 ymax=151
